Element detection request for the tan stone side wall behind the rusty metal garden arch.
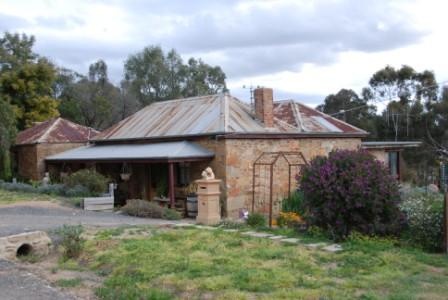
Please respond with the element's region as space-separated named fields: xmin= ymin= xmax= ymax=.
xmin=225 ymin=138 xmax=361 ymax=218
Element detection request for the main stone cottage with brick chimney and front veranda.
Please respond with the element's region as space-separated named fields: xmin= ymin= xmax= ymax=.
xmin=47 ymin=88 xmax=368 ymax=217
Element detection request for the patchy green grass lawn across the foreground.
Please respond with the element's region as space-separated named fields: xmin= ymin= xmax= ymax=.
xmin=72 ymin=228 xmax=448 ymax=299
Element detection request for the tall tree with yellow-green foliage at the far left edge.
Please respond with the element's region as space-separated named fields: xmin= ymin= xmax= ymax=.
xmin=0 ymin=33 xmax=59 ymax=129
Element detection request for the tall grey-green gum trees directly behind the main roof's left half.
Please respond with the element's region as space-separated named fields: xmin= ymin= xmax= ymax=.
xmin=125 ymin=46 xmax=226 ymax=105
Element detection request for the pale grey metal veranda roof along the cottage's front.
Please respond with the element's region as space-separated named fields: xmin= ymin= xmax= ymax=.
xmin=46 ymin=141 xmax=215 ymax=162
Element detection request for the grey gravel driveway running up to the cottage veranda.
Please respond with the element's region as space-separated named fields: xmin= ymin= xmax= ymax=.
xmin=0 ymin=201 xmax=191 ymax=237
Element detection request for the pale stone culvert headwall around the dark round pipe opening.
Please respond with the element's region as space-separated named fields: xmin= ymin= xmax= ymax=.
xmin=0 ymin=231 xmax=51 ymax=260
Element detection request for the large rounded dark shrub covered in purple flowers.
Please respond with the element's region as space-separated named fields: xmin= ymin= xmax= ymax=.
xmin=298 ymin=150 xmax=404 ymax=240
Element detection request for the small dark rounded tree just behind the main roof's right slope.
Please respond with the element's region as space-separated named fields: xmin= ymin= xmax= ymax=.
xmin=317 ymin=89 xmax=376 ymax=133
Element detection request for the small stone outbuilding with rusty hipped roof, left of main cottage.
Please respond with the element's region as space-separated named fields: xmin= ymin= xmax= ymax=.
xmin=12 ymin=118 xmax=99 ymax=180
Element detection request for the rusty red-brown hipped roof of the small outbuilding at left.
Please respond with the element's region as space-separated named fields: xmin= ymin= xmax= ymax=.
xmin=15 ymin=118 xmax=99 ymax=145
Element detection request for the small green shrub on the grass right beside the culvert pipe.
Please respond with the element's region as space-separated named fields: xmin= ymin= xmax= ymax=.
xmin=56 ymin=224 xmax=85 ymax=261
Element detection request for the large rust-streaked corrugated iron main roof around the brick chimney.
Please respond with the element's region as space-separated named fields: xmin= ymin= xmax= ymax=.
xmin=95 ymin=93 xmax=367 ymax=140
